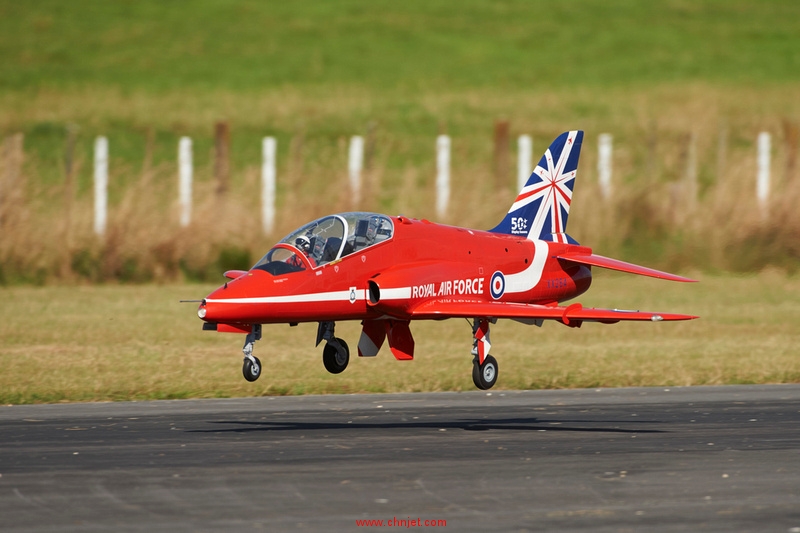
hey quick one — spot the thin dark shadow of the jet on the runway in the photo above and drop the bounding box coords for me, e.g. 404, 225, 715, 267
186, 418, 668, 433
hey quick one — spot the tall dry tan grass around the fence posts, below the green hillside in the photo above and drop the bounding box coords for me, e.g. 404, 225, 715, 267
0, 86, 800, 283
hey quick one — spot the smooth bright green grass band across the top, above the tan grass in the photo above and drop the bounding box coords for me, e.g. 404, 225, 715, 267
0, 0, 800, 93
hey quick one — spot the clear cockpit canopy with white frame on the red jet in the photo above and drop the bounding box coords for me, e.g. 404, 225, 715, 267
253, 212, 394, 276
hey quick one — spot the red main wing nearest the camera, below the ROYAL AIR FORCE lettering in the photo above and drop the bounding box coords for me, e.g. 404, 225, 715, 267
411, 298, 697, 326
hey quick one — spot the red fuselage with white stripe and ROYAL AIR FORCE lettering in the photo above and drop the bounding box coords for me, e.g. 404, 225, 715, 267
201, 217, 592, 326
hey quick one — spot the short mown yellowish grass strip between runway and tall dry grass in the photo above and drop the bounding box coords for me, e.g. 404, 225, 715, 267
0, 271, 800, 404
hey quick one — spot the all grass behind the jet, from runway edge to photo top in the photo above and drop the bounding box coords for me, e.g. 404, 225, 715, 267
0, 0, 800, 402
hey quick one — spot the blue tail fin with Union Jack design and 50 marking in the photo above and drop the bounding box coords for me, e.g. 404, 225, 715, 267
489, 131, 583, 244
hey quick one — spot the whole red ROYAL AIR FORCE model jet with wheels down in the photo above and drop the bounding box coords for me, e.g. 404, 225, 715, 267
198, 131, 697, 389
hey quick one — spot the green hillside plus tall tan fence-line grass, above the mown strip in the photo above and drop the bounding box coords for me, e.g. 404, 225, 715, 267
0, 0, 800, 284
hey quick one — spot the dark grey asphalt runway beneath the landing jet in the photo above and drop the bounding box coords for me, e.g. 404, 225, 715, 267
0, 385, 800, 532
